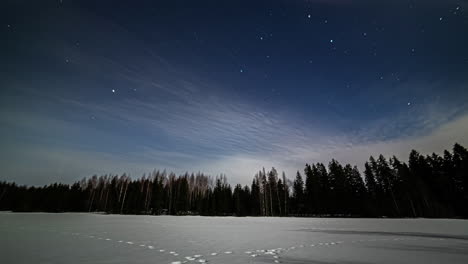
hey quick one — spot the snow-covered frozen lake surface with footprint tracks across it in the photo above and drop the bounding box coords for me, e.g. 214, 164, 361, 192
0, 213, 468, 264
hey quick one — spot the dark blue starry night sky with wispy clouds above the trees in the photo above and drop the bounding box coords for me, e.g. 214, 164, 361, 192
0, 0, 468, 185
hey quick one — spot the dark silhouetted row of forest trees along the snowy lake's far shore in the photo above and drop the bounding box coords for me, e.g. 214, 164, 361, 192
0, 144, 468, 218
